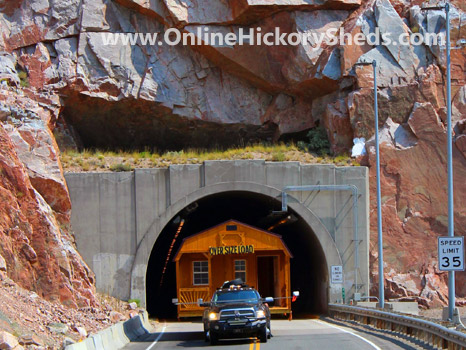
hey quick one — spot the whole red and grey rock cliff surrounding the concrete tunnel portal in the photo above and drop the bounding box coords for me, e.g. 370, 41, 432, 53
0, 0, 466, 305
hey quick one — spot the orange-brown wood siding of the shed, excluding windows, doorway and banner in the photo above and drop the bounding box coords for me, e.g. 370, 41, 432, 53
175, 221, 291, 317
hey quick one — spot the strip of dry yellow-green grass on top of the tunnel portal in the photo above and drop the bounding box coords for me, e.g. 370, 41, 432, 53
60, 143, 359, 172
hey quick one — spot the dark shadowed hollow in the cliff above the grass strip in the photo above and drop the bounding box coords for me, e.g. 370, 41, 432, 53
61, 95, 278, 152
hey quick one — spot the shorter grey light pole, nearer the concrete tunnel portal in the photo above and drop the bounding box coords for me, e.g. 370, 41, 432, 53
355, 60, 385, 309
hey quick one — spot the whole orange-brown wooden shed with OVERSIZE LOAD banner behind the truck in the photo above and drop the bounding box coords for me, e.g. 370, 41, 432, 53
174, 220, 292, 317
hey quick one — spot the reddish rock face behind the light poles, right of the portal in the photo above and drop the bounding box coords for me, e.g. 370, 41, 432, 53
369, 103, 466, 306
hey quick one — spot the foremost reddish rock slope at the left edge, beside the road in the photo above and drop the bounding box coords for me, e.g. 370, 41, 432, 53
0, 125, 95, 308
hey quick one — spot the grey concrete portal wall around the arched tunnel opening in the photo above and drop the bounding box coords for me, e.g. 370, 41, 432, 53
65, 160, 369, 305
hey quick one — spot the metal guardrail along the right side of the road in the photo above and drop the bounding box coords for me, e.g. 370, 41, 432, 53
328, 304, 466, 350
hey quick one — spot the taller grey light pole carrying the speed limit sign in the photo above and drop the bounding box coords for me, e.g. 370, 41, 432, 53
421, 2, 455, 320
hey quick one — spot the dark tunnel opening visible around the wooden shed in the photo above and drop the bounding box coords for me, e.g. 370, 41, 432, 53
146, 191, 328, 319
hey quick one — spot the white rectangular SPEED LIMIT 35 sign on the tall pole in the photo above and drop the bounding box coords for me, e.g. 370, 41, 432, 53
438, 237, 464, 271
